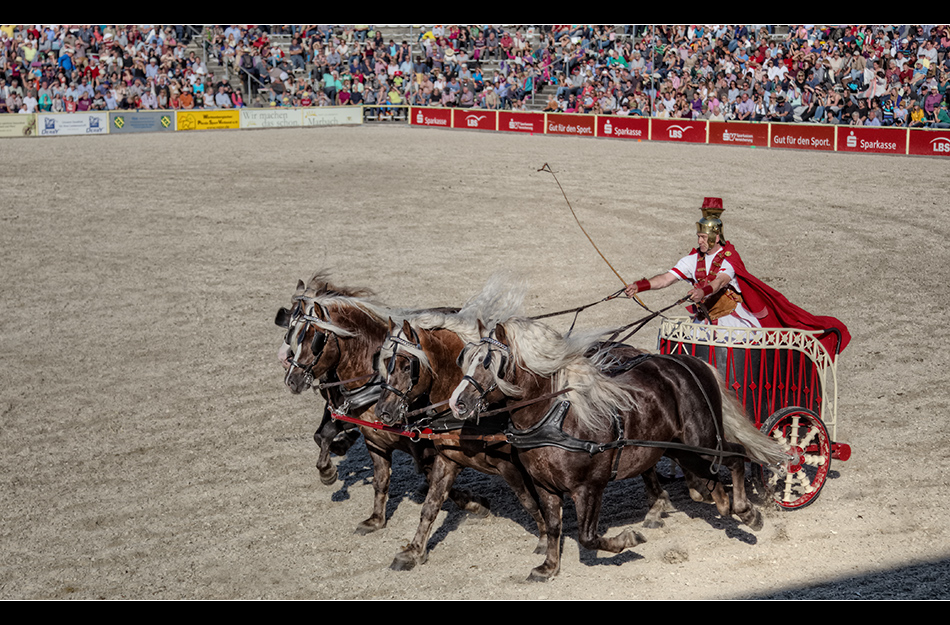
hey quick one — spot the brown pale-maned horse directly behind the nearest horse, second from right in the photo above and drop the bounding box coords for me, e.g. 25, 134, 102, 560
376, 313, 547, 570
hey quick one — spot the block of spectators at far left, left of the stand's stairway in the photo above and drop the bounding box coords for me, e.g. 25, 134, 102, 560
0, 25, 243, 113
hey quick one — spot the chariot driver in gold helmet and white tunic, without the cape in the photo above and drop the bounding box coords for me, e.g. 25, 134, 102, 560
626, 197, 762, 328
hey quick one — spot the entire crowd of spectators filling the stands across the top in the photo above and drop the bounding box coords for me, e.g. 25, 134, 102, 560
0, 24, 950, 127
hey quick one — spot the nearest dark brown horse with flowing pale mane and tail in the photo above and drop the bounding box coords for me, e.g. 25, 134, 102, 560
449, 317, 788, 581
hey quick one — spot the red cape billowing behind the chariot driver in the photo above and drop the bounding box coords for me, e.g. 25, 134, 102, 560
691, 243, 851, 358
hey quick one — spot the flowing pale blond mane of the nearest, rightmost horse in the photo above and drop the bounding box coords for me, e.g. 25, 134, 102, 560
496, 317, 638, 432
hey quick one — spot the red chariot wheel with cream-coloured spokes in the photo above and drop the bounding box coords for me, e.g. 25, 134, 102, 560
760, 407, 831, 510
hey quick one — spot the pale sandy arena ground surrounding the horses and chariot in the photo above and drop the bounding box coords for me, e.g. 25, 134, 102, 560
0, 126, 950, 599
